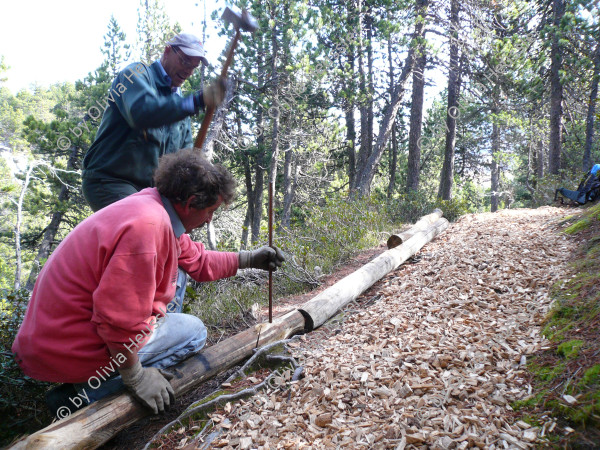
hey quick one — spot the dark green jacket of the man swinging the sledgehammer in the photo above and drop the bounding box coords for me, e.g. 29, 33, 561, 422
83, 61, 192, 190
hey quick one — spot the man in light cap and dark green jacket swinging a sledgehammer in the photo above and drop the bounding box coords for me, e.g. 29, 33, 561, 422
82, 33, 225, 211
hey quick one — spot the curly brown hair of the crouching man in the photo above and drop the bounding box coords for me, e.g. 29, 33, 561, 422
154, 148, 235, 209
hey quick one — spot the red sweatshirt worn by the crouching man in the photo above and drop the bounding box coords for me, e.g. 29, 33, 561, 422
12, 188, 238, 383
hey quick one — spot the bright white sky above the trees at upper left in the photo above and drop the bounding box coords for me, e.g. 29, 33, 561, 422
0, 0, 227, 93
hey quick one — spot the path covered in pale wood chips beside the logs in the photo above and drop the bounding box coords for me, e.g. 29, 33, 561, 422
199, 207, 575, 449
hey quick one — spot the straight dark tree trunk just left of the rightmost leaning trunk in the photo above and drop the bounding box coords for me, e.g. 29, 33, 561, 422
548, 0, 565, 175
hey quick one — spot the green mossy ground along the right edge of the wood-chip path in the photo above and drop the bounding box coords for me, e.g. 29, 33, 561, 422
513, 204, 600, 448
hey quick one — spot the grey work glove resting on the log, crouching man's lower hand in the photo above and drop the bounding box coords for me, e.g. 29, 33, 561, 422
119, 361, 175, 414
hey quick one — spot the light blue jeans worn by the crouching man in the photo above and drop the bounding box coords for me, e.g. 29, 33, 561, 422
74, 312, 207, 403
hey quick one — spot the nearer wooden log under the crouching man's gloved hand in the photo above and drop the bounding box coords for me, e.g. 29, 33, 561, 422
12, 311, 305, 449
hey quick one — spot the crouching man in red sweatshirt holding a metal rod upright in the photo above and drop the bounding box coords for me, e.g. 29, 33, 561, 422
12, 149, 284, 413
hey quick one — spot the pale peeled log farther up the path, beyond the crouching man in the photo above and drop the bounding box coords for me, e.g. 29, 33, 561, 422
299, 218, 449, 331
